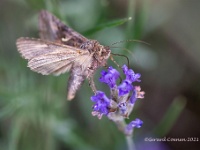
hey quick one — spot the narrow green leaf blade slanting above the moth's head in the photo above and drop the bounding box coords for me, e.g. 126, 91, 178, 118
83, 17, 131, 35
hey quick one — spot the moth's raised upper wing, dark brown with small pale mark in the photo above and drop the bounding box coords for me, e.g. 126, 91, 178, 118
39, 10, 87, 47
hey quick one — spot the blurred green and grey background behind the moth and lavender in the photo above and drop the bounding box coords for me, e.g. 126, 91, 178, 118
0, 0, 200, 150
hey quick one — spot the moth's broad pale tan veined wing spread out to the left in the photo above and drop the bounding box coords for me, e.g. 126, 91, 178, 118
17, 38, 89, 75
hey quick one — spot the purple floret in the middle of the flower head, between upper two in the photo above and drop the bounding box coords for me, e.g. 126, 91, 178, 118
118, 80, 133, 96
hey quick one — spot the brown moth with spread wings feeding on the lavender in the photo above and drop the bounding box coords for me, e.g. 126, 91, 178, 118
16, 10, 111, 100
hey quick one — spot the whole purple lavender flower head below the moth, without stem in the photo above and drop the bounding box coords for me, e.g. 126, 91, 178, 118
91, 65, 145, 134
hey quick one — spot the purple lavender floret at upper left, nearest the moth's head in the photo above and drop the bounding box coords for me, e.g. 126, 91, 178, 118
100, 67, 120, 88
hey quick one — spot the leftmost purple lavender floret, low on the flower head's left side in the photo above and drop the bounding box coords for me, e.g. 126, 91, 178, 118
91, 91, 110, 115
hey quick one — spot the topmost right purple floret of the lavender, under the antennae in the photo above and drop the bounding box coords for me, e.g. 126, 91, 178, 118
122, 65, 141, 82
